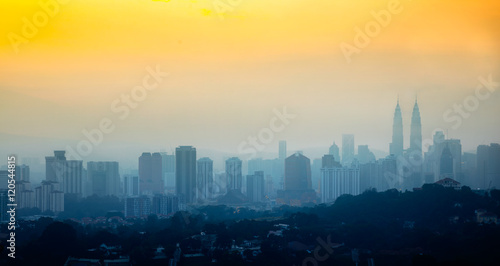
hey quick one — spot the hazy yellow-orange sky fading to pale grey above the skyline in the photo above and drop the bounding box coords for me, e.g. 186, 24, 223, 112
0, 0, 500, 164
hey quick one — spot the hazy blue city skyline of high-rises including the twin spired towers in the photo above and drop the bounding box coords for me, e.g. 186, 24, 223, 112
0, 97, 500, 220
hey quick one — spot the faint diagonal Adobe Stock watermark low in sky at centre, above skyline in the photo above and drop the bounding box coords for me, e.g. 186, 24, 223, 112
238, 106, 297, 159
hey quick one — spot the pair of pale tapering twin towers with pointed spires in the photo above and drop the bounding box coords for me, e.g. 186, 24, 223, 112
389, 98, 422, 157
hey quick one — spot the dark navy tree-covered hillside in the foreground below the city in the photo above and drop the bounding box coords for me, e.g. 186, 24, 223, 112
0, 185, 500, 265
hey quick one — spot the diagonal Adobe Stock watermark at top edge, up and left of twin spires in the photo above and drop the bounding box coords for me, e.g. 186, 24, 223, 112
340, 0, 411, 63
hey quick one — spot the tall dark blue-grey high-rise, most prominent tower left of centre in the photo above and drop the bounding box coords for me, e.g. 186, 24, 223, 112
175, 146, 196, 203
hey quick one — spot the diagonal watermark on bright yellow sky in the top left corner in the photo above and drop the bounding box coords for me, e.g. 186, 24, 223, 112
7, 0, 71, 54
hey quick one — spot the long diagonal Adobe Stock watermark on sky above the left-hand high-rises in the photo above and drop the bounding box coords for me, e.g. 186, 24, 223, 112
66, 65, 168, 160
